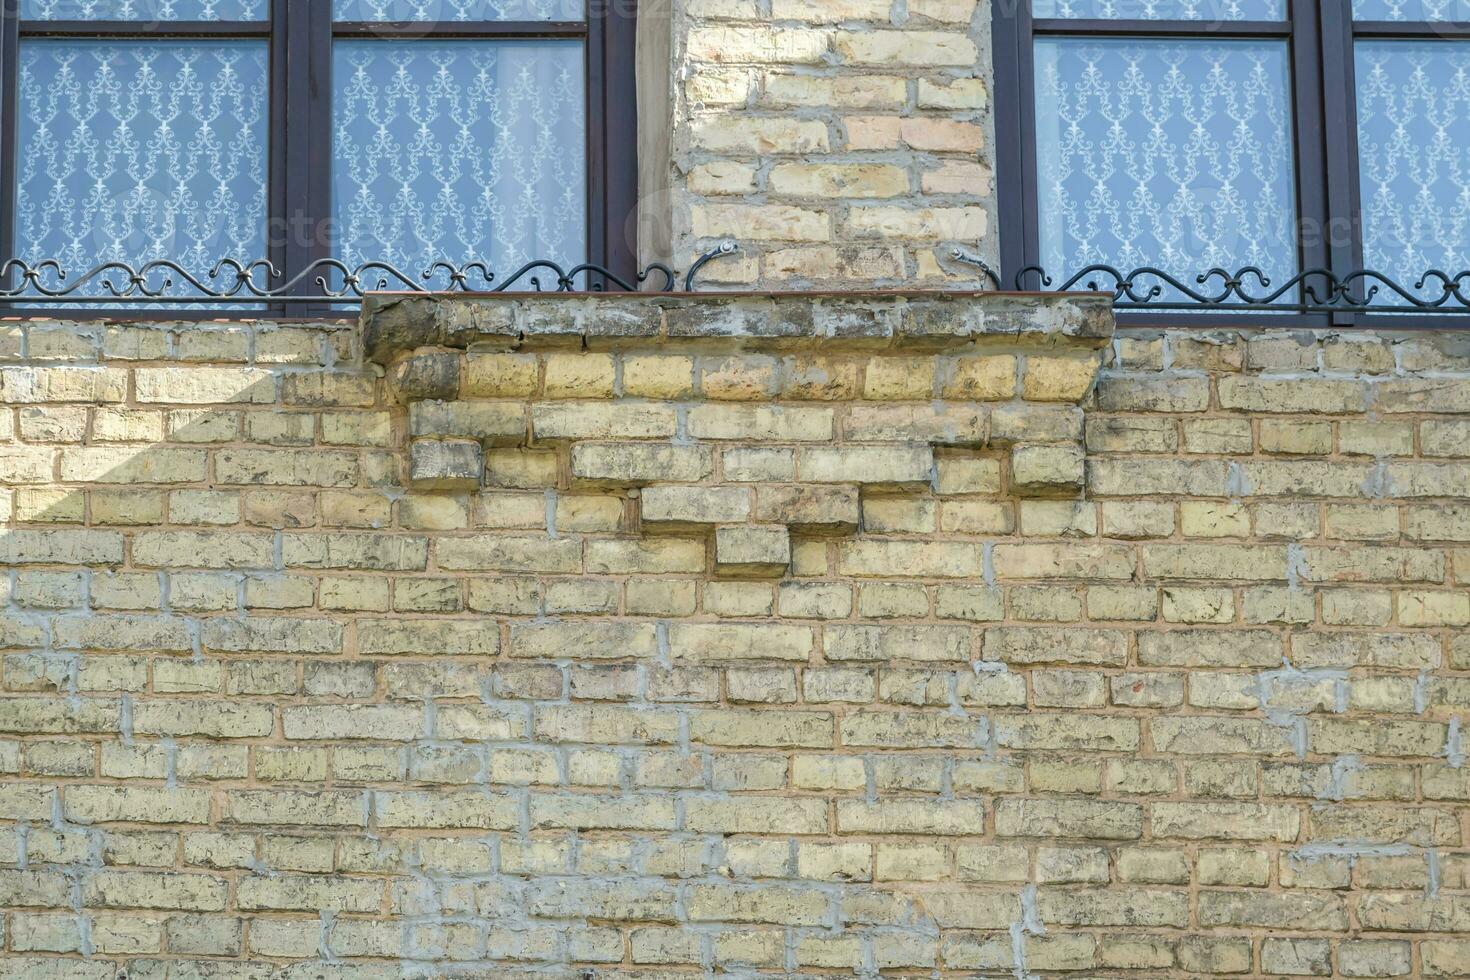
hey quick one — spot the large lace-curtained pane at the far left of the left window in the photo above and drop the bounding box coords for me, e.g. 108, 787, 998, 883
16, 40, 269, 276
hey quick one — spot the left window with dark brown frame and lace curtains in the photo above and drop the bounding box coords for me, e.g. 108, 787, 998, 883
0, 0, 637, 304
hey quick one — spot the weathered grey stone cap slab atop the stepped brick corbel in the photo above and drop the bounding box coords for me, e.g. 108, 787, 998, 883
362, 289, 1114, 364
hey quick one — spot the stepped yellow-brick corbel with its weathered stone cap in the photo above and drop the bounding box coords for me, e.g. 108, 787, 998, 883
363, 292, 1113, 577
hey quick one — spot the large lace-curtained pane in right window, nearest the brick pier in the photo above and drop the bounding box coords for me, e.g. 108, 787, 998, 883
1036, 38, 1297, 298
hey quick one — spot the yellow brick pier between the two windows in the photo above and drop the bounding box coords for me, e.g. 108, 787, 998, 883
670, 0, 995, 288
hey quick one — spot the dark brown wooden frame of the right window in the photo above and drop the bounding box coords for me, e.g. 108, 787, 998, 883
992, 0, 1470, 328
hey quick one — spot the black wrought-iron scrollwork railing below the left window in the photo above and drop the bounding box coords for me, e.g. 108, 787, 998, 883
0, 241, 739, 307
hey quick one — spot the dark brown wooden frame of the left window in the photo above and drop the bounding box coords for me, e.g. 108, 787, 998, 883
0, 0, 638, 319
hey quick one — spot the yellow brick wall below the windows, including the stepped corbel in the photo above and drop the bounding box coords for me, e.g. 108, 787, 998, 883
0, 294, 1470, 980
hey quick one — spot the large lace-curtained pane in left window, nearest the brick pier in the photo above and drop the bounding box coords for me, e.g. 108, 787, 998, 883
332, 41, 587, 285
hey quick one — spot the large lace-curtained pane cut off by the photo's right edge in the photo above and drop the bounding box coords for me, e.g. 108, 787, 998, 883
1355, 41, 1470, 300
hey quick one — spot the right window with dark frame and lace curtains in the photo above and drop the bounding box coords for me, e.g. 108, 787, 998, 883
995, 0, 1470, 323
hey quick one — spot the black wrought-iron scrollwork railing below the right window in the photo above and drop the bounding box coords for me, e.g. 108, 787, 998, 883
951, 248, 1470, 316
